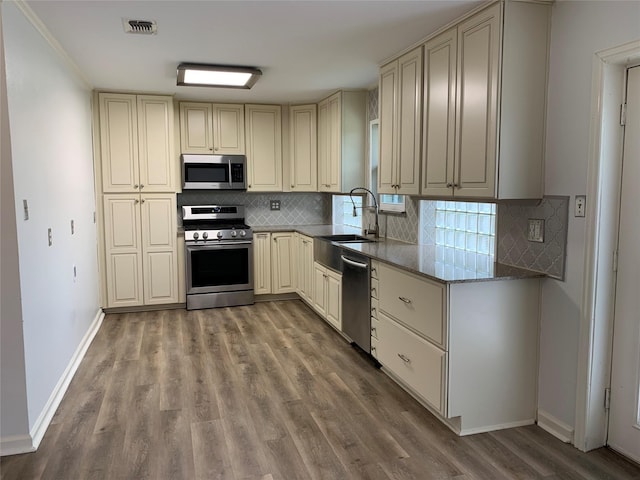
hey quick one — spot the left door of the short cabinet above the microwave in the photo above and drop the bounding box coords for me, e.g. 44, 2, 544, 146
180, 102, 213, 154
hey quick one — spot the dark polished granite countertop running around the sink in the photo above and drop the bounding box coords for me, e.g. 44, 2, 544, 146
253, 225, 545, 283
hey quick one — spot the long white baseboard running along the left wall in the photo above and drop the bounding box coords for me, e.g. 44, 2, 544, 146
28, 309, 104, 453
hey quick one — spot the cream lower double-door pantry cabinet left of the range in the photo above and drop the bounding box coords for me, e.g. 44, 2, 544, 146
103, 194, 179, 308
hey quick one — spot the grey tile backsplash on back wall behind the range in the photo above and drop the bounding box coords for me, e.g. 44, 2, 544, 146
178, 190, 331, 226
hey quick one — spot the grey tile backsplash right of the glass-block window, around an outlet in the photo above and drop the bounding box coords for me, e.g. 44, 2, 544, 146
498, 196, 569, 280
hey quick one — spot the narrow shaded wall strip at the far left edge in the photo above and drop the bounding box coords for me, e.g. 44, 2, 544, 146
0, 5, 30, 451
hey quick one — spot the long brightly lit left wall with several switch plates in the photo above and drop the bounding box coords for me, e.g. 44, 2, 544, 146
0, 2, 99, 446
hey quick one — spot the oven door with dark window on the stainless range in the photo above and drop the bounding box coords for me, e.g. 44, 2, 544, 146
187, 245, 253, 293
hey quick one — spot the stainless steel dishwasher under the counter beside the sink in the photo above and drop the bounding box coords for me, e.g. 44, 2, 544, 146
340, 249, 371, 353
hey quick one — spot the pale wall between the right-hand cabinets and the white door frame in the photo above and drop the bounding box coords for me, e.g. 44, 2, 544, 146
539, 0, 640, 428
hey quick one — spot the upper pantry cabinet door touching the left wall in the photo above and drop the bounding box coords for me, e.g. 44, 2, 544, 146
98, 93, 140, 193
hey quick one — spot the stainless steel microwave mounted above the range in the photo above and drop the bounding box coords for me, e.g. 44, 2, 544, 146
180, 155, 247, 190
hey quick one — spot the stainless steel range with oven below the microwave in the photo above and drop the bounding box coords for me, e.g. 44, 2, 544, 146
182, 205, 253, 310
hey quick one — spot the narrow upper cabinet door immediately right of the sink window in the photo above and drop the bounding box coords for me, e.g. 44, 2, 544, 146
378, 61, 398, 194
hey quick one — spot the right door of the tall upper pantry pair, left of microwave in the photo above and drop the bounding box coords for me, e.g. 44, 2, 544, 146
137, 95, 178, 192
